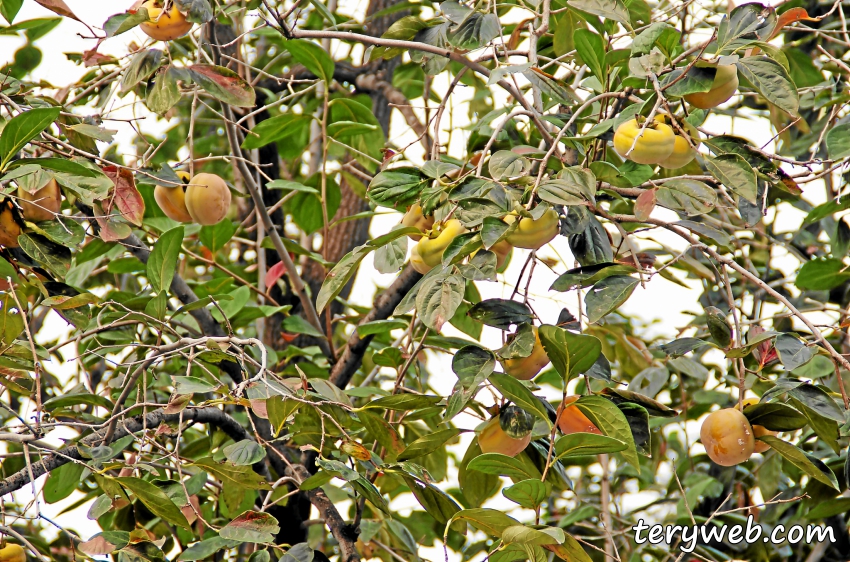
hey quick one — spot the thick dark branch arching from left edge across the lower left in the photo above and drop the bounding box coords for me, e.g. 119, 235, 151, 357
0, 408, 252, 497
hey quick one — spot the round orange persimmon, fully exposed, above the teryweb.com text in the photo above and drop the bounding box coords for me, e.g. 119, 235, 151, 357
699, 408, 755, 466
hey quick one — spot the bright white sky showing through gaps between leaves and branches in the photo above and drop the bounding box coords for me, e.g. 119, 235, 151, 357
0, 0, 836, 560
